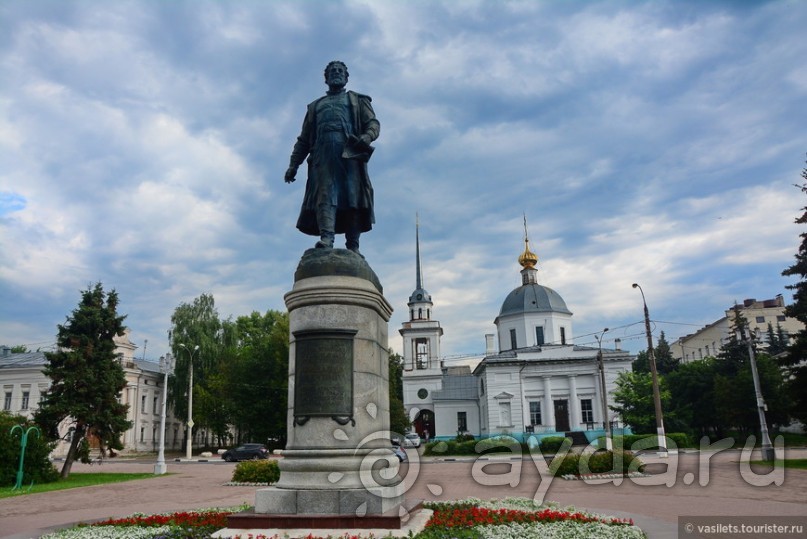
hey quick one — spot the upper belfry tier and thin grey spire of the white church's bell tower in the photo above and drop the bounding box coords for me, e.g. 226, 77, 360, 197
400, 215, 443, 374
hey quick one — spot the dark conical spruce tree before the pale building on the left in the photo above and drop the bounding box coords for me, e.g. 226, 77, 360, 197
36, 283, 131, 477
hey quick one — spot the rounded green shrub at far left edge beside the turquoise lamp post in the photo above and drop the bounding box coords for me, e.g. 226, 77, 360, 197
0, 412, 59, 488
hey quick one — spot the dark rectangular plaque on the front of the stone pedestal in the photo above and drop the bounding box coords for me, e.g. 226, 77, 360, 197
294, 329, 356, 425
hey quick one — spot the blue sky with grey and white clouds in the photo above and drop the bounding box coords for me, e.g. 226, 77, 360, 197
0, 0, 807, 359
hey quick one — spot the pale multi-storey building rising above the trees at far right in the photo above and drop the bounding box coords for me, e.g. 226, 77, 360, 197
671, 294, 804, 363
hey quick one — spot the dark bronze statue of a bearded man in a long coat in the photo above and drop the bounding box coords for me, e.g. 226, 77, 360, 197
286, 61, 381, 253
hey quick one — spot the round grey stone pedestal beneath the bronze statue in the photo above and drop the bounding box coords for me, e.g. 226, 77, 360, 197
241, 249, 406, 527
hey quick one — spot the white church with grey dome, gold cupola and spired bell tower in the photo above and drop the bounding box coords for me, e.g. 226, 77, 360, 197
399, 226, 635, 443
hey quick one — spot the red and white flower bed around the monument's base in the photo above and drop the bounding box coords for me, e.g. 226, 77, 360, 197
43, 498, 646, 539
